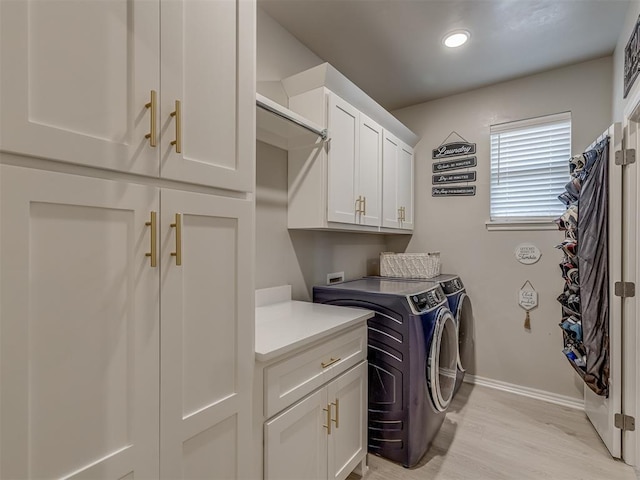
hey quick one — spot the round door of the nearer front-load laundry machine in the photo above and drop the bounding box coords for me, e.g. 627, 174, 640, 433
427, 308, 458, 412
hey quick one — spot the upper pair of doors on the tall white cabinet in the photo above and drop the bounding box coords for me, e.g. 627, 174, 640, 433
0, 0, 255, 191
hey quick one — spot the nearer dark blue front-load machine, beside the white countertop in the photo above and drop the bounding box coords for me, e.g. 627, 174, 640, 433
313, 278, 458, 467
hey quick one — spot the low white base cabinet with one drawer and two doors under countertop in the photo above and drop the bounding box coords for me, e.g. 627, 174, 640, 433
256, 325, 367, 480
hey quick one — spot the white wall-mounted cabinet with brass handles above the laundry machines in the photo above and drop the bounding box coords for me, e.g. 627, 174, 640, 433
283, 64, 418, 233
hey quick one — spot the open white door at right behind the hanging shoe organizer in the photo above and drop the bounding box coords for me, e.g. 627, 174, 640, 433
584, 123, 622, 458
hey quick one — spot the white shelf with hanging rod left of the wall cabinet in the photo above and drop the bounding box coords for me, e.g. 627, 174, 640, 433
256, 93, 327, 150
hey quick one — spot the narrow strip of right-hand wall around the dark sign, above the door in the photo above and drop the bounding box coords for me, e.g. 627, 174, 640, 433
612, 0, 640, 122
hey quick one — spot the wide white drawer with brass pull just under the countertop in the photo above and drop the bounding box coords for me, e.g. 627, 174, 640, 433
264, 325, 367, 418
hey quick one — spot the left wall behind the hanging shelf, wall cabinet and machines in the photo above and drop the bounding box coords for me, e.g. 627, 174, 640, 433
255, 8, 387, 300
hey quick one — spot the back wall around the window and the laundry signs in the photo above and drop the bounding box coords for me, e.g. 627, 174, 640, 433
390, 57, 612, 398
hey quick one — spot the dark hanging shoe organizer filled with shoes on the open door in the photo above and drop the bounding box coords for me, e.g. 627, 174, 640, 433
556, 138, 609, 396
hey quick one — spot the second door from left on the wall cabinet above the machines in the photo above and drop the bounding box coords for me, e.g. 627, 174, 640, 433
356, 113, 382, 227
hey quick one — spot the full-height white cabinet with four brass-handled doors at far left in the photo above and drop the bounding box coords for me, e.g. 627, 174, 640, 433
0, 0, 255, 479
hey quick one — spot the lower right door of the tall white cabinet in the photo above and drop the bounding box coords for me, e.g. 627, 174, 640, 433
160, 189, 255, 480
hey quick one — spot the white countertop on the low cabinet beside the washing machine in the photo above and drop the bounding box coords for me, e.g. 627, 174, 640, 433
256, 287, 373, 362
